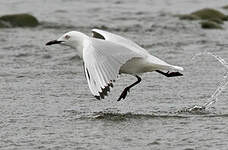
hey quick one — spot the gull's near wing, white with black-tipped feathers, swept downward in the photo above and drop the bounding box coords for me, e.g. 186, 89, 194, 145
83, 38, 140, 99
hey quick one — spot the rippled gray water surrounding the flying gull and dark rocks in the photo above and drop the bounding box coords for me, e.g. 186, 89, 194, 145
0, 0, 228, 150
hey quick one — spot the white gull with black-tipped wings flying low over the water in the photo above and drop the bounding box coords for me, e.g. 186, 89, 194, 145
46, 29, 183, 101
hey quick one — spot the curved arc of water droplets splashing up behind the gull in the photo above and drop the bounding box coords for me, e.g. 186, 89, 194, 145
185, 52, 228, 112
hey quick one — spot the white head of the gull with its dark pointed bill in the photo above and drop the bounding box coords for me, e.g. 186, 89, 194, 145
46, 31, 86, 48
